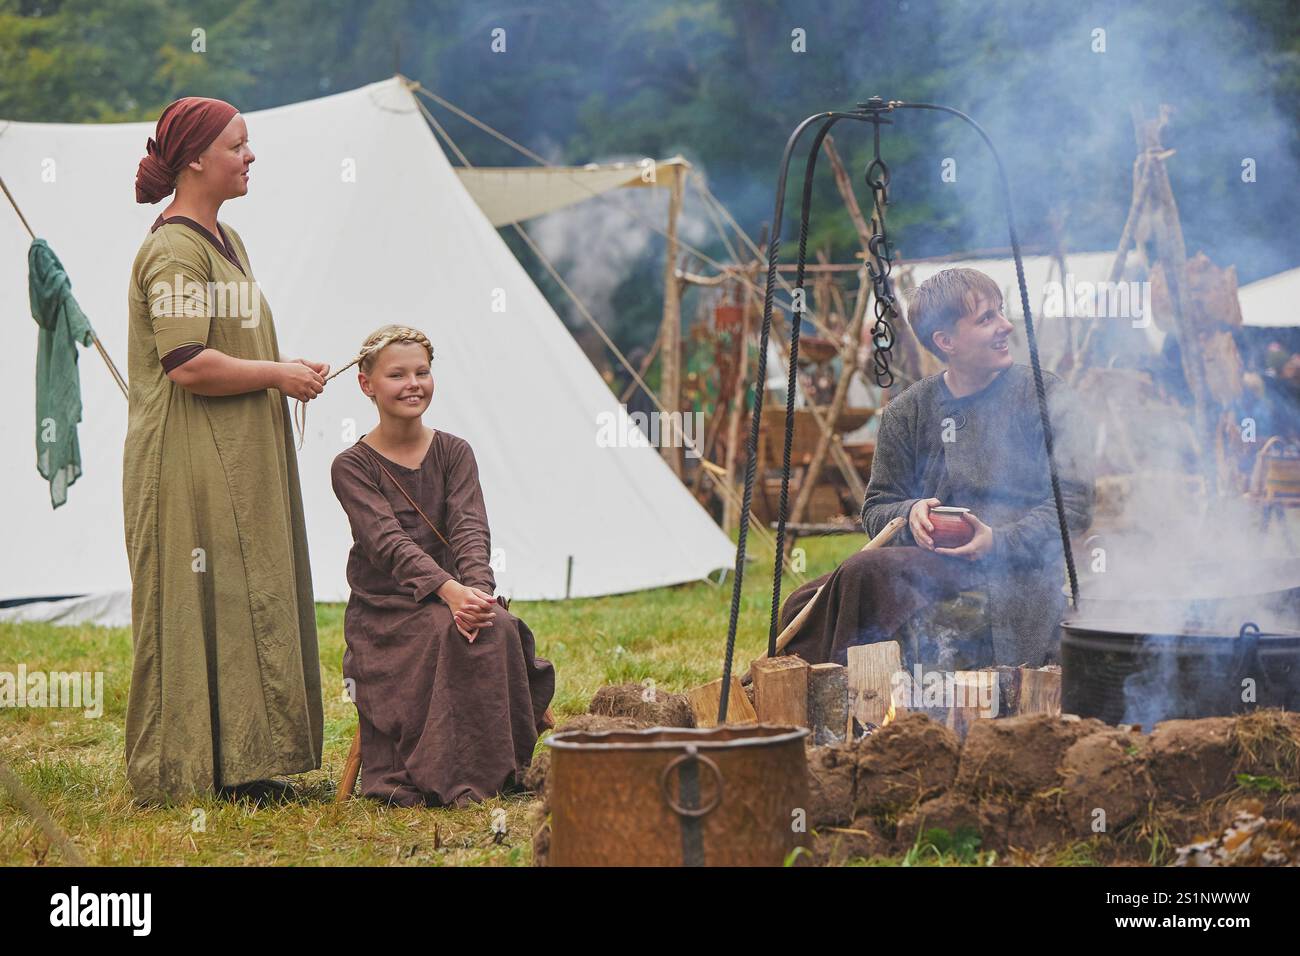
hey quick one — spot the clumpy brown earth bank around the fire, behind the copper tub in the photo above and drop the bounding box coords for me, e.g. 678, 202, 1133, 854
525, 702, 1300, 866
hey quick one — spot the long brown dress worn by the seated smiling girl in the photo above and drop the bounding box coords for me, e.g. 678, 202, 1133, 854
330, 431, 555, 806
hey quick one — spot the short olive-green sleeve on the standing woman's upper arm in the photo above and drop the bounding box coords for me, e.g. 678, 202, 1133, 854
140, 235, 212, 362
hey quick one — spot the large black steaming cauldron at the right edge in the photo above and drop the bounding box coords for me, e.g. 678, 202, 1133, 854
1061, 620, 1300, 730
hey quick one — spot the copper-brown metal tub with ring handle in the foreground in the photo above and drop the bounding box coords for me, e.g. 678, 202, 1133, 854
546, 724, 809, 866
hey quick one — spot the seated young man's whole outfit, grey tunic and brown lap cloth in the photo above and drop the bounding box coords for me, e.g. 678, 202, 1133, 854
764, 365, 1096, 669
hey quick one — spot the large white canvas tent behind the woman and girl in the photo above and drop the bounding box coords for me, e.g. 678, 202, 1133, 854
0, 78, 735, 623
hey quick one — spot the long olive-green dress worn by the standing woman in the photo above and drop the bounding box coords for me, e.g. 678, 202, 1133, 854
122, 217, 322, 801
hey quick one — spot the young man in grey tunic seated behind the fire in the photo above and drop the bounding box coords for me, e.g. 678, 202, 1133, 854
781, 269, 1093, 669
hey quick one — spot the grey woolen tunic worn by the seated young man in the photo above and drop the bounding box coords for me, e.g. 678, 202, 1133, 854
862, 365, 1093, 666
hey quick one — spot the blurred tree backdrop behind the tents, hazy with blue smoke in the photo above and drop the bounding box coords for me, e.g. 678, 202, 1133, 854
0, 0, 1300, 345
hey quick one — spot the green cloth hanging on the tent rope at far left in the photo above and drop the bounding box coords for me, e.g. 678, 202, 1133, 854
27, 239, 95, 507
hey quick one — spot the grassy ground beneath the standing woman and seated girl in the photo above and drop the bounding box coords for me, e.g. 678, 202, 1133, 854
0, 536, 865, 866
